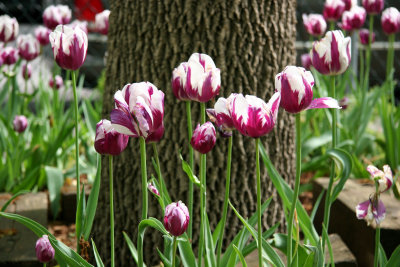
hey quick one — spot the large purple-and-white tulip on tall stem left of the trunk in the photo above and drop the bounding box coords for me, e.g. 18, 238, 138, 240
50, 25, 88, 70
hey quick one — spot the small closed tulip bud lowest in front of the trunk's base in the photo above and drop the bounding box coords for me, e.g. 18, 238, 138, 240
164, 201, 190, 236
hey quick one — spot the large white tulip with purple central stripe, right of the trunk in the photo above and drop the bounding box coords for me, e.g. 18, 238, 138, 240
311, 31, 351, 75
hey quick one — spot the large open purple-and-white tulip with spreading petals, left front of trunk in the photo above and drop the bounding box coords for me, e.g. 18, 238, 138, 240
111, 82, 164, 142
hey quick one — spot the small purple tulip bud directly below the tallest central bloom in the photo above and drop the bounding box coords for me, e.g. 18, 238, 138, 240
190, 121, 217, 154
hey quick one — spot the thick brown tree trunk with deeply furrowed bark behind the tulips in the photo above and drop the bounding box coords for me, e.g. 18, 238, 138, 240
93, 0, 296, 266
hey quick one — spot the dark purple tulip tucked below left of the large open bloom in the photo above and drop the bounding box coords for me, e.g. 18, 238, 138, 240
94, 120, 129, 156
